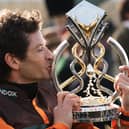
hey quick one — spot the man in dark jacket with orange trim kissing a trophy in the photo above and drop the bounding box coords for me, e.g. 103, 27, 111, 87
0, 10, 129, 129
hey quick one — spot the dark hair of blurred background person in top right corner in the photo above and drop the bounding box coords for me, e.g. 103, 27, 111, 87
120, 0, 129, 21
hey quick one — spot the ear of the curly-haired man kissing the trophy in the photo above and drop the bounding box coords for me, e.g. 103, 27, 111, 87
4, 53, 20, 70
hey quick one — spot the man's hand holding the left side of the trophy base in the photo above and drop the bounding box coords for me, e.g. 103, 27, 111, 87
54, 92, 80, 128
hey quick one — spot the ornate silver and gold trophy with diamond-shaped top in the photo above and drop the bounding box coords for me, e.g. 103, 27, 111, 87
52, 1, 129, 122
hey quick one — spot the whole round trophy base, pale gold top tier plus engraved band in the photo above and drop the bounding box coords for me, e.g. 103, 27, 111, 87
73, 97, 119, 122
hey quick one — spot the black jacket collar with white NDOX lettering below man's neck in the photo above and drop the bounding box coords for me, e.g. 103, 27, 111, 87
0, 81, 38, 101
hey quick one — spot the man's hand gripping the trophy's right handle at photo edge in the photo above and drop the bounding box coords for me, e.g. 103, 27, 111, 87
114, 66, 129, 111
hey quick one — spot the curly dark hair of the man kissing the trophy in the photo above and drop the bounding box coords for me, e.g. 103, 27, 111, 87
0, 9, 41, 78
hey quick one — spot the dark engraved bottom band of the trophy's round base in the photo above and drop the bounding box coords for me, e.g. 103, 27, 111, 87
73, 104, 120, 122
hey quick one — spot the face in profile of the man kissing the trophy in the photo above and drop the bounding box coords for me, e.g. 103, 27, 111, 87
20, 31, 53, 82
